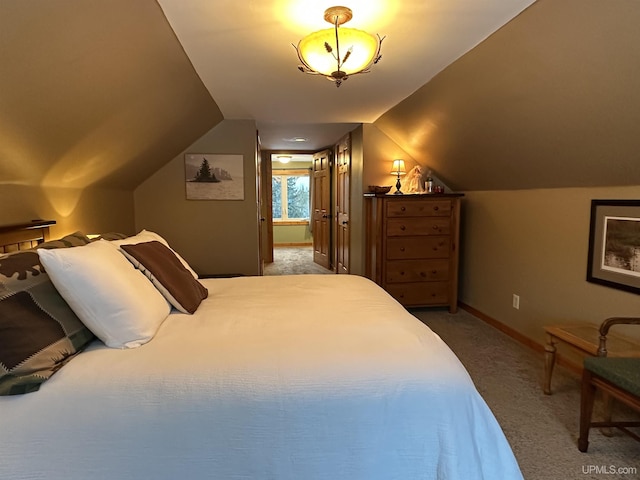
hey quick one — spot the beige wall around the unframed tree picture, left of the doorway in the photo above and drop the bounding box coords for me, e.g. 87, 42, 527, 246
134, 120, 259, 275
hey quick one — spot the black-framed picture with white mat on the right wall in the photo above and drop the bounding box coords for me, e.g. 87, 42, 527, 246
587, 200, 640, 294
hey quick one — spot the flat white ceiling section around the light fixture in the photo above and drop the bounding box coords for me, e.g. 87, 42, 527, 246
158, 0, 533, 150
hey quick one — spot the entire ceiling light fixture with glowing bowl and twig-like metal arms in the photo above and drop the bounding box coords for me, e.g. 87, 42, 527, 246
293, 7, 385, 87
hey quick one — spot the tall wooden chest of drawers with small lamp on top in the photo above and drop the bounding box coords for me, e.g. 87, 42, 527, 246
365, 194, 463, 313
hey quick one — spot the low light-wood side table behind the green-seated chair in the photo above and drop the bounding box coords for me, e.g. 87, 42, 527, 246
543, 324, 640, 395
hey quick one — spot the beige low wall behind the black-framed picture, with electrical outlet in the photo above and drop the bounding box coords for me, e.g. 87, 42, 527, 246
460, 187, 640, 344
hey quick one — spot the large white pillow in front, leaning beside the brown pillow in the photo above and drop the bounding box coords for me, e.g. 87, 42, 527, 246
38, 240, 171, 348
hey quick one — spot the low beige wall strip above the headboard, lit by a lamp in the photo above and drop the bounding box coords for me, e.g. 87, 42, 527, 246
0, 185, 135, 238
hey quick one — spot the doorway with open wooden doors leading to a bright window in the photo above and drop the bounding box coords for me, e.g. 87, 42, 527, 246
260, 134, 351, 275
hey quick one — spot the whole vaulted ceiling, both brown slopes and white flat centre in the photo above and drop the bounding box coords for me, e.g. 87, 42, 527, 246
0, 0, 640, 190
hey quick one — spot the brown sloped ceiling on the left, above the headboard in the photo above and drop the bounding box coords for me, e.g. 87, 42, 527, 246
0, 0, 222, 190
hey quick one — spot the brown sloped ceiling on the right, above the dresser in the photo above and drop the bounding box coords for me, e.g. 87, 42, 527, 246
375, 0, 640, 190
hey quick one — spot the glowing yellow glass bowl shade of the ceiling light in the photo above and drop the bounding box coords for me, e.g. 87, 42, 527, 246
298, 27, 380, 77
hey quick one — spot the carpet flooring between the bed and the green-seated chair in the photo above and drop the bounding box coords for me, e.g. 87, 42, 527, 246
411, 309, 640, 480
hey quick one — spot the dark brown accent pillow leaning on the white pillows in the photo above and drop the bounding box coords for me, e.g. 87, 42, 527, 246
120, 240, 209, 313
